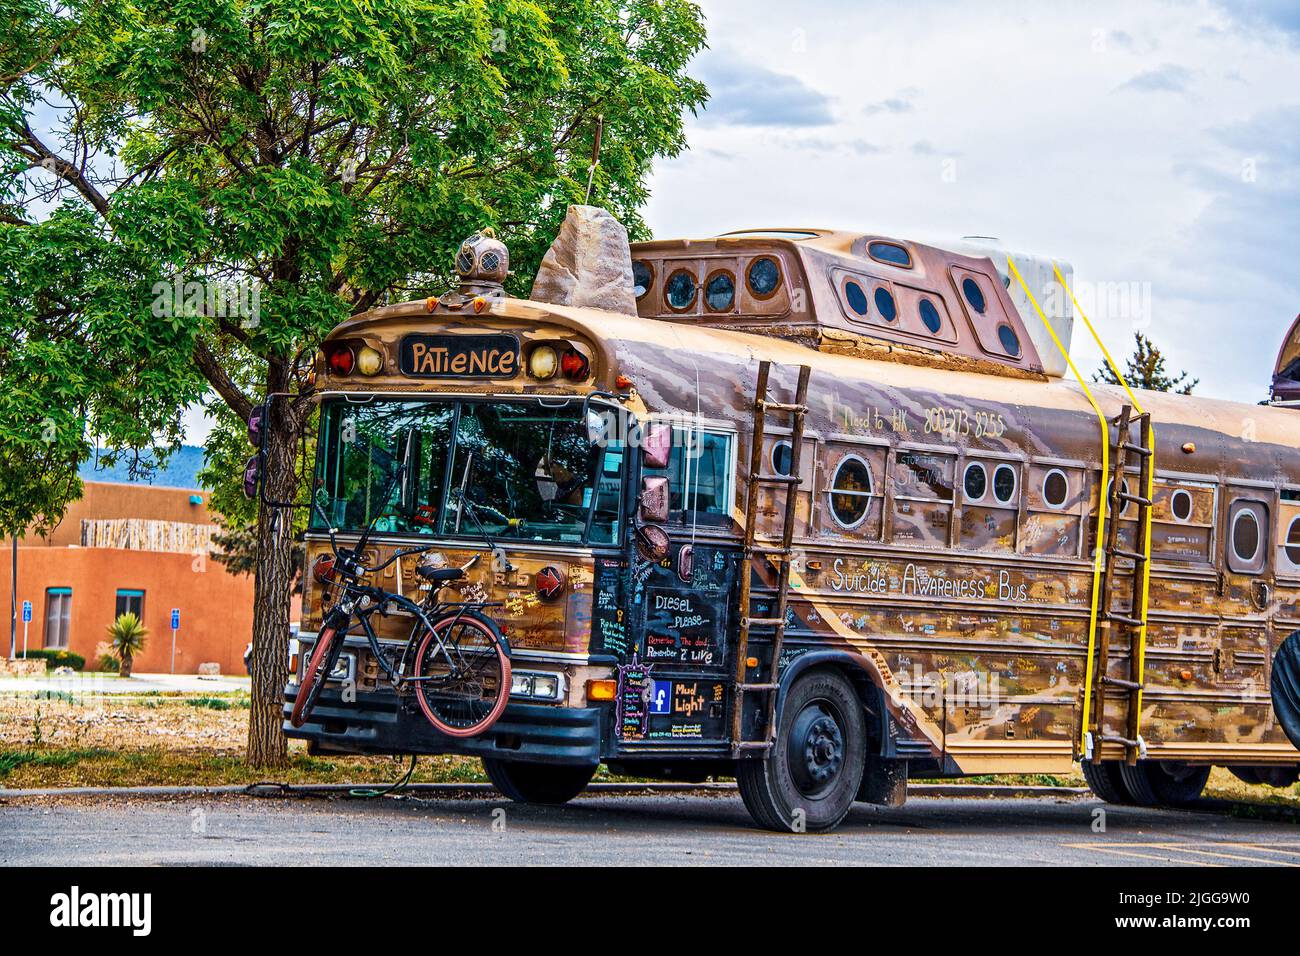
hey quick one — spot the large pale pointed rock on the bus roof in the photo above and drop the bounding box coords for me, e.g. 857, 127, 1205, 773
529, 206, 637, 315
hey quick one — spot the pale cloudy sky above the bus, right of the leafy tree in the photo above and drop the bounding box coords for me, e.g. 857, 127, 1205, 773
646, 0, 1300, 402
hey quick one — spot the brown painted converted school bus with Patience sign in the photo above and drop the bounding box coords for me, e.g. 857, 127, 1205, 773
286, 218, 1300, 829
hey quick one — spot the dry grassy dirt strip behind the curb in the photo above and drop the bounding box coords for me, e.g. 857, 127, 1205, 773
0, 693, 1300, 806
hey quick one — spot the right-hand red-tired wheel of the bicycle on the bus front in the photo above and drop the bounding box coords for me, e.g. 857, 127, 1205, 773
415, 614, 510, 737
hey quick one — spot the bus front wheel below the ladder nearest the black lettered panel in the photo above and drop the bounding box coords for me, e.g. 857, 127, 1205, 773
736, 671, 867, 832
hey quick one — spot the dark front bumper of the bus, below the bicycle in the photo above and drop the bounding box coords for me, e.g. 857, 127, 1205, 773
283, 685, 602, 766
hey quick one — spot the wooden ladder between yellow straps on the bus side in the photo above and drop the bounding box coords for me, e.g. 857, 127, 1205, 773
1088, 405, 1154, 763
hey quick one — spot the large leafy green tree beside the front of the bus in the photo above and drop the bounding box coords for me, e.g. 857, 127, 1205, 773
0, 0, 705, 766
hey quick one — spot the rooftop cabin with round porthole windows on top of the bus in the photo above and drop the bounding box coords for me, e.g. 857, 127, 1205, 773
632, 229, 1074, 378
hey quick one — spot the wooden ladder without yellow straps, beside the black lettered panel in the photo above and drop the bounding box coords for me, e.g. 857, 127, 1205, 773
731, 362, 811, 757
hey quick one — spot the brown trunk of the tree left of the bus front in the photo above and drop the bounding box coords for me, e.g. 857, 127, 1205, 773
248, 388, 298, 767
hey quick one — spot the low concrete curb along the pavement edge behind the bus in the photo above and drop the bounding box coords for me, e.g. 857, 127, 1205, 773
0, 782, 1088, 800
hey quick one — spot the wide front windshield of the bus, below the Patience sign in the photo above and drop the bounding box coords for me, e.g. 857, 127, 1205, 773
312, 399, 625, 544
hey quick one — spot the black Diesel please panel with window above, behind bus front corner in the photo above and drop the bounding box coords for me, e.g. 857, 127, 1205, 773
615, 425, 740, 749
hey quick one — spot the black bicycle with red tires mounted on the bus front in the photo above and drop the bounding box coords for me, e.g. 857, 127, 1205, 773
290, 501, 511, 737
